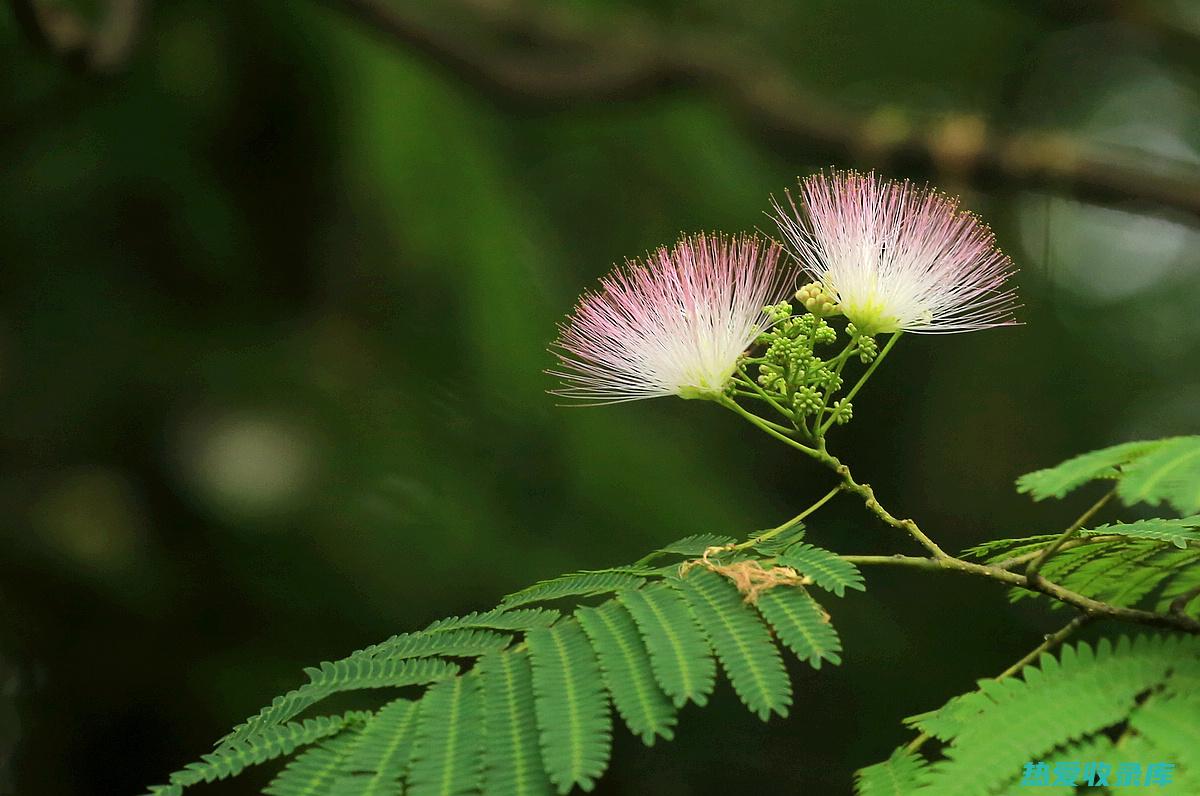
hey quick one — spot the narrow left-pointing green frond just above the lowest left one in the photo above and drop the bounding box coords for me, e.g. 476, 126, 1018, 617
221, 658, 458, 747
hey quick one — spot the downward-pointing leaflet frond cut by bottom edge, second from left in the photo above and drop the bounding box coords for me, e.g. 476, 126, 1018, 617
340, 699, 420, 796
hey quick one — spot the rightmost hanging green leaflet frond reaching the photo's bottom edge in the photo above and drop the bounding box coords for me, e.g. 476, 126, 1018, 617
526, 621, 612, 794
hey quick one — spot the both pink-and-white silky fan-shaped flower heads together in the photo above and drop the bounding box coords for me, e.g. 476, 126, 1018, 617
553, 172, 1015, 403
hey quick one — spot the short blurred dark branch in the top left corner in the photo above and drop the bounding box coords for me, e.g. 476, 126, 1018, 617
12, 0, 149, 74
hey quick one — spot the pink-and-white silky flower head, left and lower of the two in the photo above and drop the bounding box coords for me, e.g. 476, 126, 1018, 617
550, 234, 790, 403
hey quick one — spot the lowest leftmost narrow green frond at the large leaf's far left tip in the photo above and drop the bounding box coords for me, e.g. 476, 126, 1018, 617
162, 711, 371, 785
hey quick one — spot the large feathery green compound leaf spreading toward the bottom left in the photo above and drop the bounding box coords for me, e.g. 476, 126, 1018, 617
151, 529, 864, 796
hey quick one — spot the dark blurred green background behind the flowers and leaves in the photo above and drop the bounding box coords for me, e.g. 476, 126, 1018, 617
0, 0, 1200, 796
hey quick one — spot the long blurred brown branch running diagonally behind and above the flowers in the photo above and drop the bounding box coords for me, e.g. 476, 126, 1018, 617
320, 0, 1200, 216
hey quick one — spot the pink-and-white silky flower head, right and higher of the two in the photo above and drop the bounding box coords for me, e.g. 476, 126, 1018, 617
774, 172, 1016, 335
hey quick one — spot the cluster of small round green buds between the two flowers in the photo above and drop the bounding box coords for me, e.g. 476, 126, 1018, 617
731, 283, 878, 437
